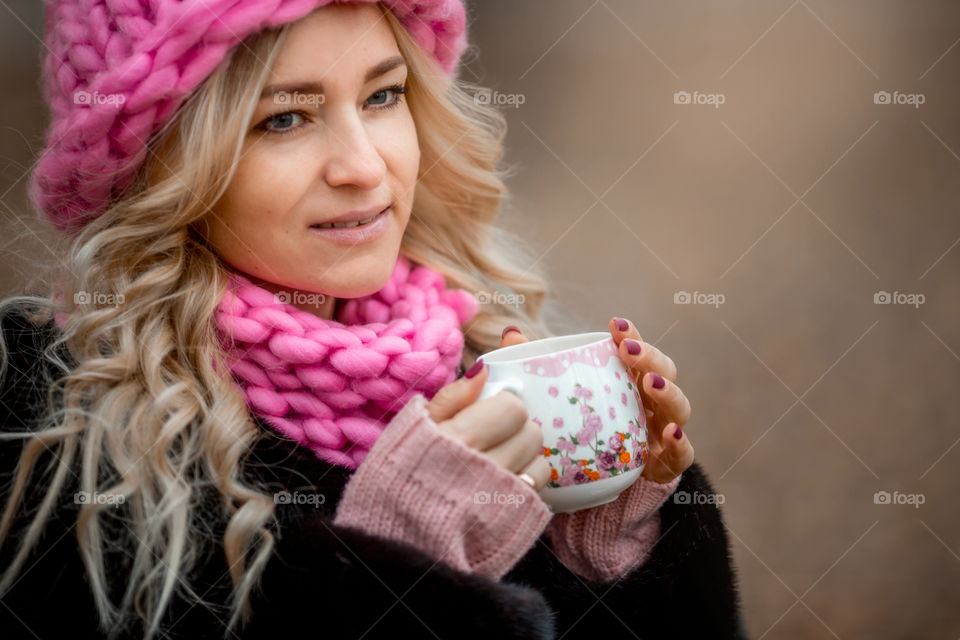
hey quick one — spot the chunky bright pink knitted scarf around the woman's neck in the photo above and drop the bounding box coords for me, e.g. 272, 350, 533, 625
216, 256, 477, 469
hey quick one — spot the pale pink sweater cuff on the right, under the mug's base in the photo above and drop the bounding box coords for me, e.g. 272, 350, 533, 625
547, 474, 682, 582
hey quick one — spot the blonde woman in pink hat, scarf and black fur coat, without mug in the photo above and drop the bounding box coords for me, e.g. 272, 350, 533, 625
0, 0, 739, 638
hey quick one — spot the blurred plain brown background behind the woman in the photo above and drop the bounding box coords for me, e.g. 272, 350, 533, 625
0, 0, 960, 639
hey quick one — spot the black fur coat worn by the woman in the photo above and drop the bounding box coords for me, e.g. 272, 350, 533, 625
0, 314, 744, 640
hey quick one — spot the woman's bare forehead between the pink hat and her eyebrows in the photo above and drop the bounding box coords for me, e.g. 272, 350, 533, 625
268, 3, 399, 85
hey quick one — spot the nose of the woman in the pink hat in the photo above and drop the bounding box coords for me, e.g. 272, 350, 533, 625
325, 112, 387, 189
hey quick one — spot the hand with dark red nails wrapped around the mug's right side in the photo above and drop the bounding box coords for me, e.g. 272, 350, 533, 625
500, 318, 693, 484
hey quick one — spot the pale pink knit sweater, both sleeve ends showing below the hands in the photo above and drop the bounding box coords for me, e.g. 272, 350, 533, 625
334, 394, 680, 581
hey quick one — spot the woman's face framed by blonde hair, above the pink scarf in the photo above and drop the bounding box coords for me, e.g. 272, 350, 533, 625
201, 4, 420, 317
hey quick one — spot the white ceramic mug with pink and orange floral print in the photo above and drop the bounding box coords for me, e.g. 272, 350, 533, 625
478, 331, 647, 513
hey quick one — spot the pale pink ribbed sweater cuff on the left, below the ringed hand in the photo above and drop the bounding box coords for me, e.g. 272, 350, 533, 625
334, 394, 552, 580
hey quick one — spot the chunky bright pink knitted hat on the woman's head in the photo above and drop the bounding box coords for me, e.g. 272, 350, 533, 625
29, 0, 466, 231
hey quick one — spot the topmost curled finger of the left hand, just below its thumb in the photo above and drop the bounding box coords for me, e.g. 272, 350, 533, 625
443, 391, 528, 452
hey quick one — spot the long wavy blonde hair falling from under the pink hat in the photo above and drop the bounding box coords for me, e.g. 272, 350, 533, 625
0, 5, 576, 638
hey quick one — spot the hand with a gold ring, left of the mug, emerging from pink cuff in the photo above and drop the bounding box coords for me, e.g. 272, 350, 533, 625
427, 365, 550, 492
